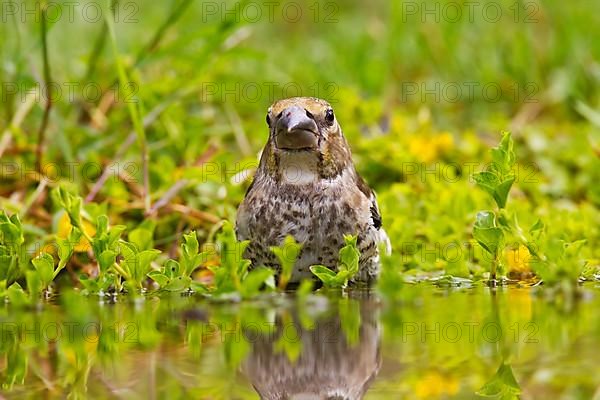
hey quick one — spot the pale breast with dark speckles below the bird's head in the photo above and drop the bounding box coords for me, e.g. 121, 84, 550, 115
237, 170, 381, 282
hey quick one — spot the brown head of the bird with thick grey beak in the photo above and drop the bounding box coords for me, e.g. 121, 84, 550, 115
261, 97, 352, 182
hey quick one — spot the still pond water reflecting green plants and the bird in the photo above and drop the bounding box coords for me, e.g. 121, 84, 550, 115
0, 284, 600, 399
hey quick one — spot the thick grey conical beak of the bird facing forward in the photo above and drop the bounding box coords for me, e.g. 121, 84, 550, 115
275, 106, 319, 150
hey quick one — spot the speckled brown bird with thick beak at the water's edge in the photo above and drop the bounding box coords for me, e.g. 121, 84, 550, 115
235, 97, 391, 285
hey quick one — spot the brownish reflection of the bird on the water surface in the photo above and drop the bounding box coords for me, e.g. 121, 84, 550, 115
242, 300, 381, 400
